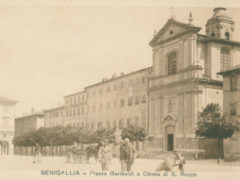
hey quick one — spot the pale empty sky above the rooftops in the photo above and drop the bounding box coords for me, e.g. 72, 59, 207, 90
0, 0, 240, 116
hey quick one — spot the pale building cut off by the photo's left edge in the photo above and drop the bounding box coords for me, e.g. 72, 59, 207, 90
0, 97, 17, 155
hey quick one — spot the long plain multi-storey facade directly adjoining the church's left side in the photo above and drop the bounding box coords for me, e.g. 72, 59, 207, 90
86, 68, 151, 129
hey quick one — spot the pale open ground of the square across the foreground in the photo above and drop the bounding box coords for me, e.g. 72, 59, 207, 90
0, 156, 240, 180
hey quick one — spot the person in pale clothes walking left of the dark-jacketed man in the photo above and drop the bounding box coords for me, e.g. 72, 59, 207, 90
98, 140, 112, 171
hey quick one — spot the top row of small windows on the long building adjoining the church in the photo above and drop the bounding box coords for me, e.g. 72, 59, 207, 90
88, 76, 147, 97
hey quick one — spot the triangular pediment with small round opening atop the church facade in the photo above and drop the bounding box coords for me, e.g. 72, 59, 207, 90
150, 19, 201, 46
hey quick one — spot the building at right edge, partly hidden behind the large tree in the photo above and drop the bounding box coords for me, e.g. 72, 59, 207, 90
218, 65, 240, 160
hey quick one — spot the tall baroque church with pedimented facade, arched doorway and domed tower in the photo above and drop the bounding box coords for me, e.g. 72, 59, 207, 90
148, 7, 240, 156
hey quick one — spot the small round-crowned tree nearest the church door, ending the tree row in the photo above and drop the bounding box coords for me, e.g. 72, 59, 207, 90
121, 125, 148, 149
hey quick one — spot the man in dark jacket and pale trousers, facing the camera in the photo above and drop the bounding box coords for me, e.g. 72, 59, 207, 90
120, 138, 135, 171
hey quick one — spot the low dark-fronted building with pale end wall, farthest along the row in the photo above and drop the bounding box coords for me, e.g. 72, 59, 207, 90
15, 112, 44, 137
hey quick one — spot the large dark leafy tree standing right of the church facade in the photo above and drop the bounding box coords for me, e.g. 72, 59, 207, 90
196, 103, 240, 159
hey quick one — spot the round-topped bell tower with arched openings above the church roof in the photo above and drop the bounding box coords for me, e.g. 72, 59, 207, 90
206, 7, 235, 40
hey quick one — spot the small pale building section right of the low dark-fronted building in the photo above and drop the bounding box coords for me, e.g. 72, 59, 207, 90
44, 106, 65, 127
